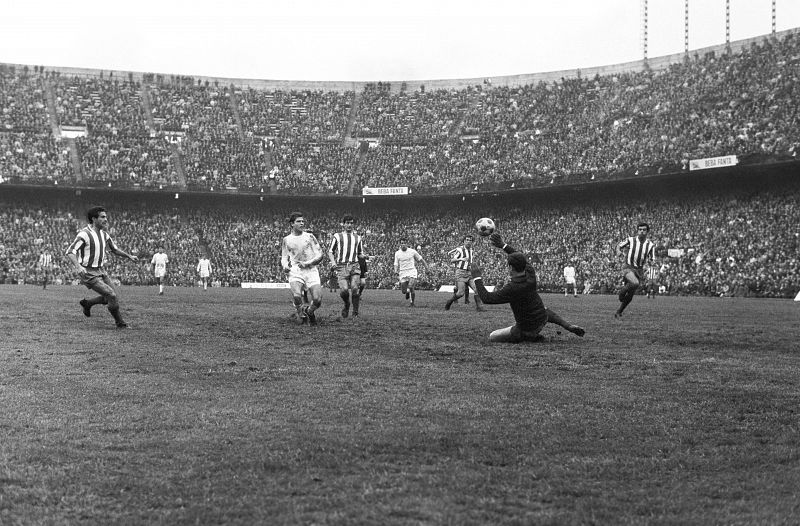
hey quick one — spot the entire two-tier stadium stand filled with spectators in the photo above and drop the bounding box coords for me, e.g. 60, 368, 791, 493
0, 31, 800, 297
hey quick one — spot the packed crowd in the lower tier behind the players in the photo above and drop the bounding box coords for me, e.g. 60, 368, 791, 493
0, 177, 800, 297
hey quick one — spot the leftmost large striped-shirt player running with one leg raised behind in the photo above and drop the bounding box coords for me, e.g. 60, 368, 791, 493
66, 206, 139, 329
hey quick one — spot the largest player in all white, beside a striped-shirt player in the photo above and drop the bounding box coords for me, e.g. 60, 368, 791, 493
281, 212, 323, 325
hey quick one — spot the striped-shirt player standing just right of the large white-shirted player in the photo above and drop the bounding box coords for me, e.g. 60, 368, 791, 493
328, 214, 366, 318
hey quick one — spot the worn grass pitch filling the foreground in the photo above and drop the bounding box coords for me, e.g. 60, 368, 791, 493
0, 285, 800, 525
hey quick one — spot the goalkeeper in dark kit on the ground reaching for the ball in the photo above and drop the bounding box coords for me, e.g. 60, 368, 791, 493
470, 232, 586, 343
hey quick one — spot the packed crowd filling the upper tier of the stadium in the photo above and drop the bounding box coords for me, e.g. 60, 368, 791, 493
0, 29, 800, 195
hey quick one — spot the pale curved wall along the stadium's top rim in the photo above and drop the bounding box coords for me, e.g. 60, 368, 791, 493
6, 28, 800, 92
